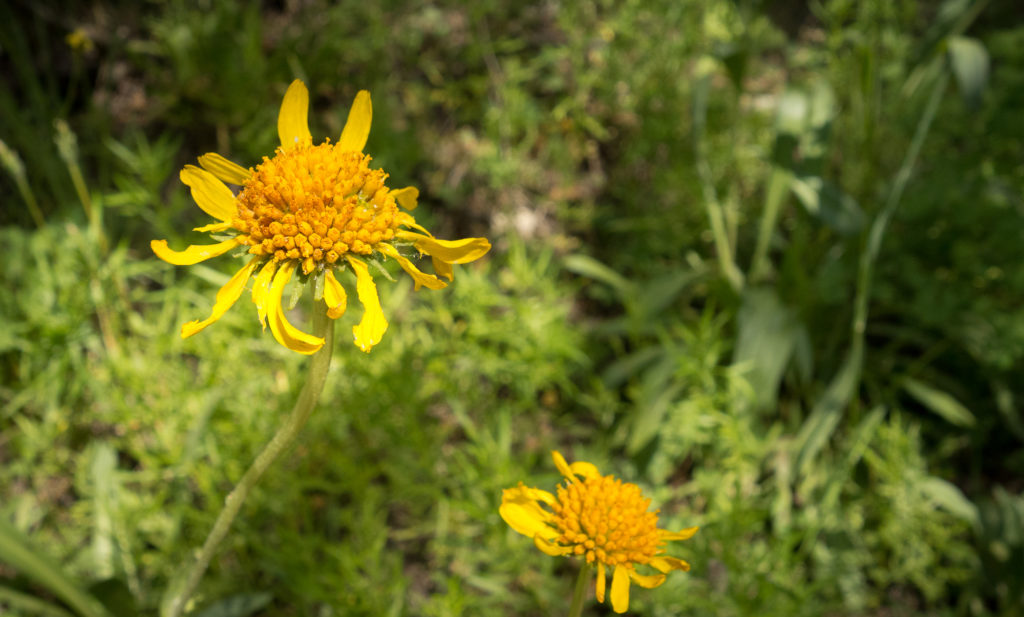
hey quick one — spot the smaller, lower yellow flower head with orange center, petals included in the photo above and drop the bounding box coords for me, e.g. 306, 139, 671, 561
499, 451, 697, 613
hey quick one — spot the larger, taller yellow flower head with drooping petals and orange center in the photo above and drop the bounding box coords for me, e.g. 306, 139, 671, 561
150, 80, 490, 354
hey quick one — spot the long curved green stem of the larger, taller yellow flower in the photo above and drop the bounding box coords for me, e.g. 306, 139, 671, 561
160, 301, 334, 617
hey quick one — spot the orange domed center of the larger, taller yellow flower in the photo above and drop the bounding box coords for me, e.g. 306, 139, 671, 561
231, 140, 398, 274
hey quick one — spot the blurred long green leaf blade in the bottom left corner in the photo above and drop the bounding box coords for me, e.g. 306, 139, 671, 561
0, 517, 110, 617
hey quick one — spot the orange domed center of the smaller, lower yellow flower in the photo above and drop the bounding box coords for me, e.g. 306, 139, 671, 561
552, 476, 660, 566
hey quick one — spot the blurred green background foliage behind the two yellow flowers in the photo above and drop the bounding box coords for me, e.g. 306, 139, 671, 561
0, 0, 1024, 617
